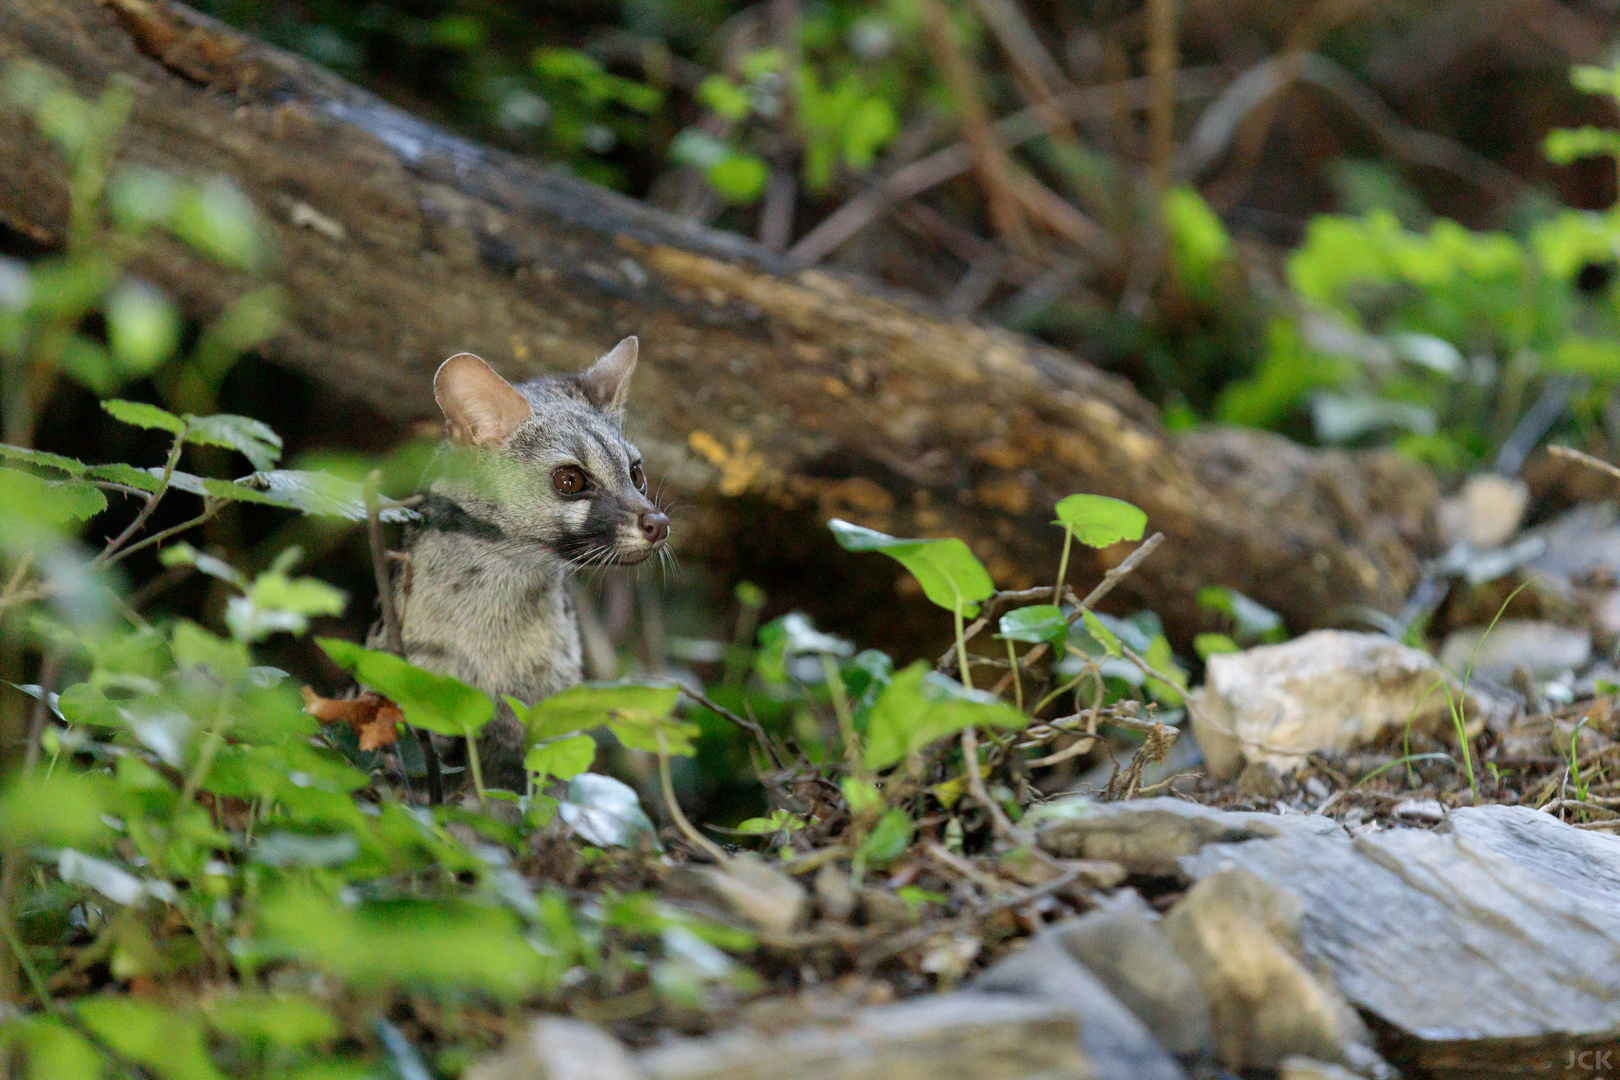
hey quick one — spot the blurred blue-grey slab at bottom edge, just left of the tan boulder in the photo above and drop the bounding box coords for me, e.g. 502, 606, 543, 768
974, 928, 1207, 1080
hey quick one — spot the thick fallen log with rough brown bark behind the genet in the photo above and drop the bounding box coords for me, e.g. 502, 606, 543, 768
0, 0, 1435, 635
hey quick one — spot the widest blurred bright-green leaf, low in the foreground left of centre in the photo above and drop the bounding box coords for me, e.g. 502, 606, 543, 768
258, 887, 546, 999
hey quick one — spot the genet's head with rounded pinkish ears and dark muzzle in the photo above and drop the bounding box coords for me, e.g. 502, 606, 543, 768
433, 337, 669, 567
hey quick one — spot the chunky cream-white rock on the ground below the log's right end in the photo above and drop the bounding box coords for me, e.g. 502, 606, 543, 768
1191, 630, 1499, 779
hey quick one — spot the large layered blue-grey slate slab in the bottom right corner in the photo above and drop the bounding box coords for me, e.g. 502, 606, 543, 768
1183, 806, 1620, 1077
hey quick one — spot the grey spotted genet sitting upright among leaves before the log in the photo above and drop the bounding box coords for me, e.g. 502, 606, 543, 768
382, 337, 667, 789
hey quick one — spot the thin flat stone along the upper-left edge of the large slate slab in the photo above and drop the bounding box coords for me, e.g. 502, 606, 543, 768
1037, 797, 1348, 878
